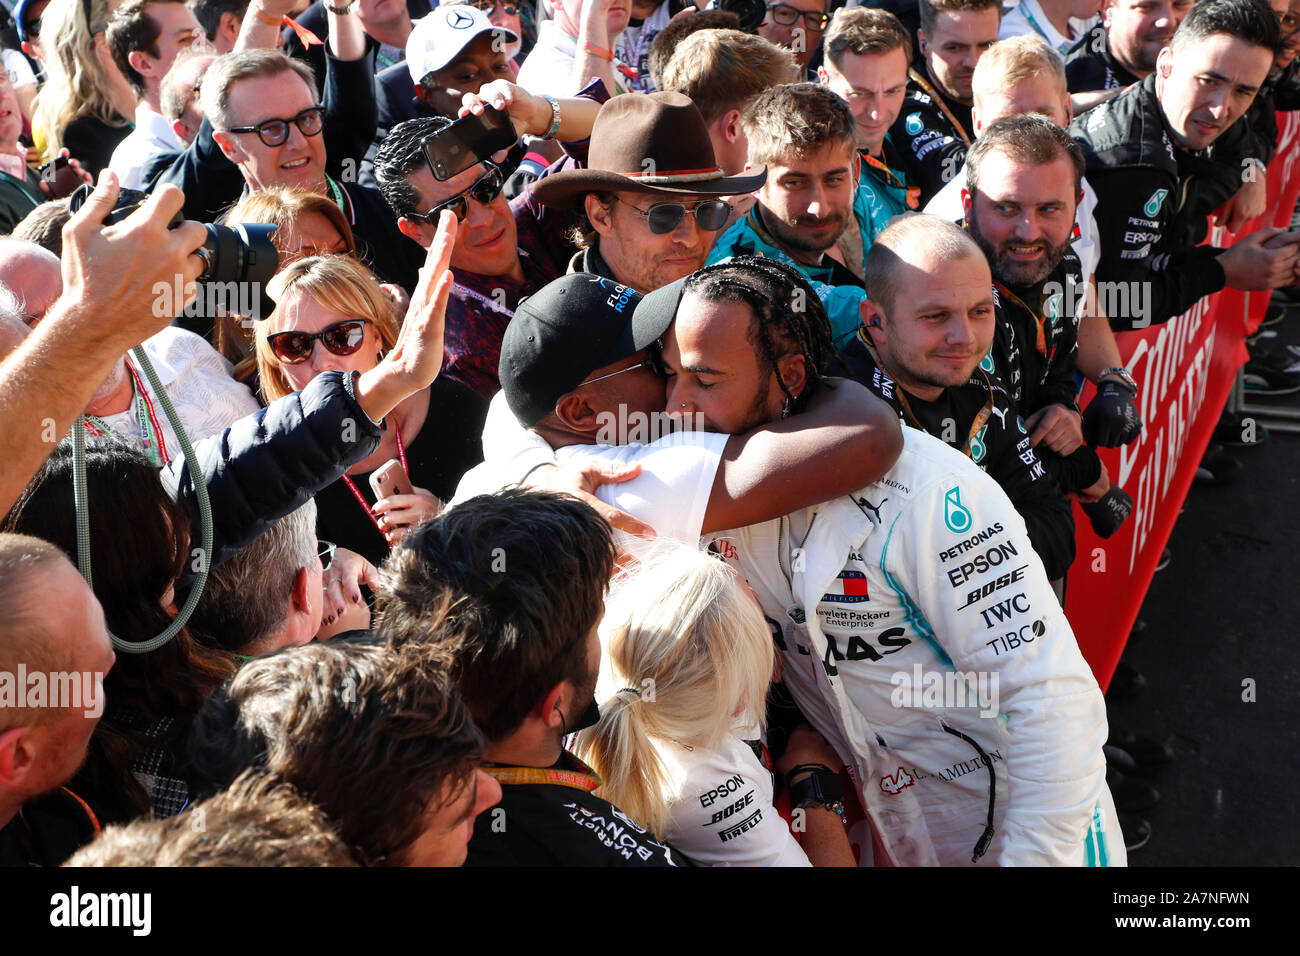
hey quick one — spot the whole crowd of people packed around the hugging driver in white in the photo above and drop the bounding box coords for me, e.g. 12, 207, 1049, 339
0, 0, 1300, 866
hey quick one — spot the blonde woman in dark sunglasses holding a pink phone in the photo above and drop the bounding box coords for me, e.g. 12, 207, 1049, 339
255, 255, 488, 564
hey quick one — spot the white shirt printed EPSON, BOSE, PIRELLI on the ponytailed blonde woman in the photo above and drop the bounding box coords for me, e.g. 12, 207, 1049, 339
655, 723, 813, 866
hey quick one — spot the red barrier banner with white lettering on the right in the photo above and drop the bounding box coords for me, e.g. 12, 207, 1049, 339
1066, 113, 1300, 688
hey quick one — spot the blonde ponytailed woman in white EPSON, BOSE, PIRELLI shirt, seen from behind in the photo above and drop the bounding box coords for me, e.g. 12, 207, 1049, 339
577, 545, 853, 866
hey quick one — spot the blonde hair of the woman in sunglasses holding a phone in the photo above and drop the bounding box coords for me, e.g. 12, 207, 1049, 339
254, 255, 398, 402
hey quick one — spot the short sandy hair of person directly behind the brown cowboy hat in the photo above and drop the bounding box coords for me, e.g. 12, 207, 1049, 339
659, 30, 800, 124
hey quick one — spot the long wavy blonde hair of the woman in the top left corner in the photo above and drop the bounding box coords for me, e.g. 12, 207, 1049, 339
33, 0, 128, 160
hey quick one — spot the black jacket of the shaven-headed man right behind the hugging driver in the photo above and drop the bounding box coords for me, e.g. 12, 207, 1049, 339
828, 333, 1075, 580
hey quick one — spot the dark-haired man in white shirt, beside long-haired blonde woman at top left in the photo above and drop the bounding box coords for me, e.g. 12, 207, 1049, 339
107, 0, 200, 189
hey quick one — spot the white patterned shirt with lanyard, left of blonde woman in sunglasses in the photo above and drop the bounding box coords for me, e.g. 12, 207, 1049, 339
94, 326, 260, 458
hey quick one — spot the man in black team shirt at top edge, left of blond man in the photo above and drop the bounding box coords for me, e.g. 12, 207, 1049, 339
889, 0, 1002, 204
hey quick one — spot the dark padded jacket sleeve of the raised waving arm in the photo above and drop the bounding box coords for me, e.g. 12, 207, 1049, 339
161, 372, 384, 587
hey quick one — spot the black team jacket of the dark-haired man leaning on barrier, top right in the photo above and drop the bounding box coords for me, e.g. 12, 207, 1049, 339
1070, 75, 1242, 332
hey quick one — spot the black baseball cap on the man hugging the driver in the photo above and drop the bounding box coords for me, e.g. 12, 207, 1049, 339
498, 272, 686, 428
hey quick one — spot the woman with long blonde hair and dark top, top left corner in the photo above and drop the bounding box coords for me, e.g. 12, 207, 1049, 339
31, 0, 137, 179
